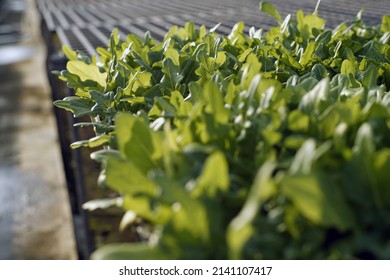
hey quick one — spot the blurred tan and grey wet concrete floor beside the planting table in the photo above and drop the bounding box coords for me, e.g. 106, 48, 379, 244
0, 0, 76, 259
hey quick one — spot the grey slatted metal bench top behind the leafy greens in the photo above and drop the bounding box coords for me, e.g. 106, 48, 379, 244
37, 0, 390, 54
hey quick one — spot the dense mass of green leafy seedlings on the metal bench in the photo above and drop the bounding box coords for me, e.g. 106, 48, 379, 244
55, 2, 390, 259
